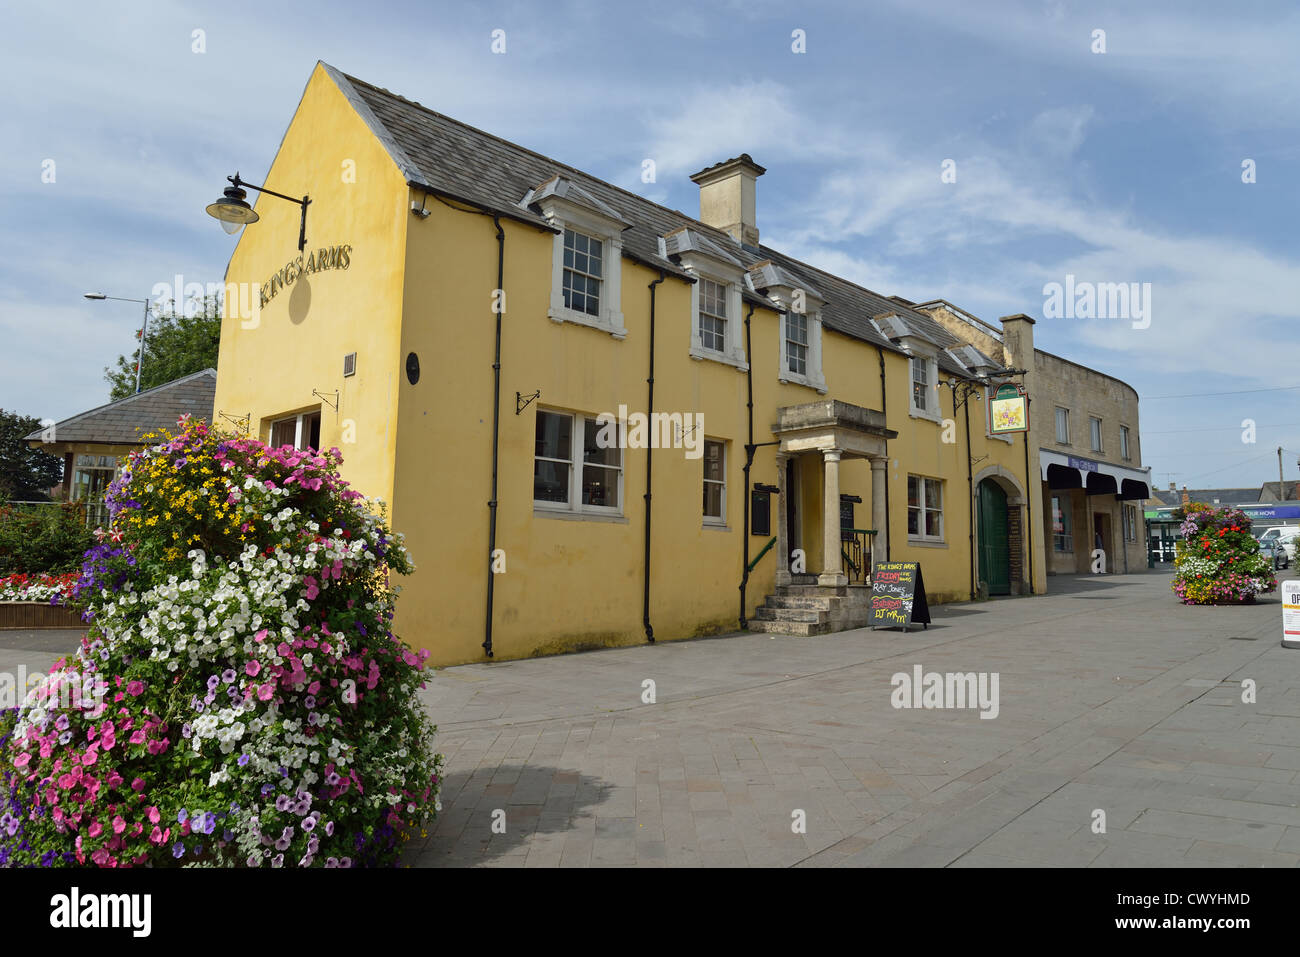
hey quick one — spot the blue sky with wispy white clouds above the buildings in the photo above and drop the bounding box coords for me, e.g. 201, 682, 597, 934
0, 0, 1300, 489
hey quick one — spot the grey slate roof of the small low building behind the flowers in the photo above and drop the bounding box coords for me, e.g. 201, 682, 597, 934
25, 369, 217, 445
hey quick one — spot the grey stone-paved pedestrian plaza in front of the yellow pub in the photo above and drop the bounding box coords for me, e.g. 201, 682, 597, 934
0, 572, 1300, 867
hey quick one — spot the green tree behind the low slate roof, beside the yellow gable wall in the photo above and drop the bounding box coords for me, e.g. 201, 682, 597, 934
104, 295, 221, 402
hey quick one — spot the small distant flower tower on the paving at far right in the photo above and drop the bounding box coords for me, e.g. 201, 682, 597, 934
1171, 502, 1278, 605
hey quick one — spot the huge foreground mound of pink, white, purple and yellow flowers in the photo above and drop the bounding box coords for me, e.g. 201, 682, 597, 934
0, 420, 442, 867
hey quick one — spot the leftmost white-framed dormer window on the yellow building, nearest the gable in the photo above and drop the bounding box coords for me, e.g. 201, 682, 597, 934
520, 176, 629, 339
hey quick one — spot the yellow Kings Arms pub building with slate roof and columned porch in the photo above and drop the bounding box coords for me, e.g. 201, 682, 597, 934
215, 64, 1047, 664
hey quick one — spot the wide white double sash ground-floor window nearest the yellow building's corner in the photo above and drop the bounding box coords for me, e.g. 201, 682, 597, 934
533, 410, 623, 515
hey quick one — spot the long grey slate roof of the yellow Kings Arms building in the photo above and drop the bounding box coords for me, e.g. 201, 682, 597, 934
321, 64, 1001, 376
